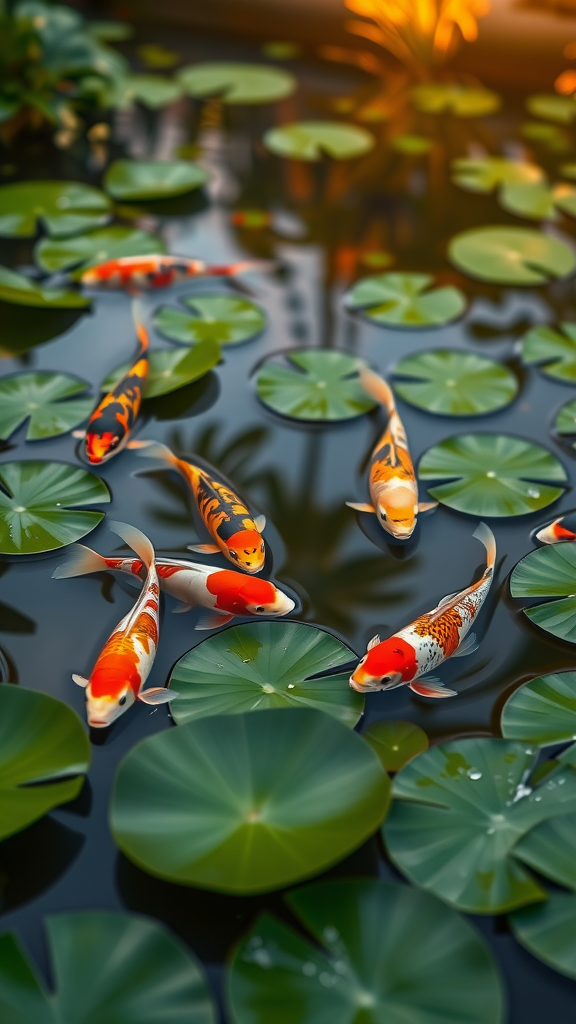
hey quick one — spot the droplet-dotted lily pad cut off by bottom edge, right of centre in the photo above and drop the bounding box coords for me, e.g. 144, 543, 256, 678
228, 879, 504, 1024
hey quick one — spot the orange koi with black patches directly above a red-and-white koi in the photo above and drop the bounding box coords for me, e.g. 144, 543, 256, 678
128, 441, 266, 572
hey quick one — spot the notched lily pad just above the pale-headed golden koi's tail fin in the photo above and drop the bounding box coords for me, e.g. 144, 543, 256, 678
344, 273, 466, 328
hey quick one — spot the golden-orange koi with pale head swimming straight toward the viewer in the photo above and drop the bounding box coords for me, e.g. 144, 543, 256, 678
346, 367, 438, 541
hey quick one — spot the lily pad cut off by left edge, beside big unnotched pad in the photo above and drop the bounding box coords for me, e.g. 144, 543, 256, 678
0, 684, 90, 839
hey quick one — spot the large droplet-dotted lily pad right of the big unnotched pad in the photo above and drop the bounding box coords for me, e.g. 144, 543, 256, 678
383, 738, 576, 913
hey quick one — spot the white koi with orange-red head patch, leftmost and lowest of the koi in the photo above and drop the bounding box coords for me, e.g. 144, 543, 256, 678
72, 522, 178, 729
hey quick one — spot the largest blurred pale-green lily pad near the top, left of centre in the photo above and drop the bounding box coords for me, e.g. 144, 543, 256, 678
176, 60, 297, 104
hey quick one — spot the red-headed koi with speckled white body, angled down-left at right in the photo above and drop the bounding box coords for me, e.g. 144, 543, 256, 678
349, 522, 496, 697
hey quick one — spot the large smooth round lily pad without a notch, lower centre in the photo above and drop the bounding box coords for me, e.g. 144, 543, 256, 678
110, 708, 387, 895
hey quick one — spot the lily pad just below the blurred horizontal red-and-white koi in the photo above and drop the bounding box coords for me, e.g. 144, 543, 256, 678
154, 295, 266, 345
